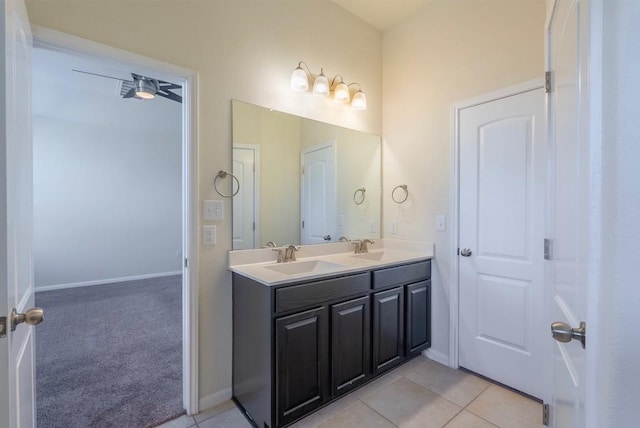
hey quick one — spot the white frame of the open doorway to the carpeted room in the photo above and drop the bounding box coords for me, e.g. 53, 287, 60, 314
32, 25, 199, 415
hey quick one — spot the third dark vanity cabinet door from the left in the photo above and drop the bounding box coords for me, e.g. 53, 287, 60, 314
373, 287, 404, 374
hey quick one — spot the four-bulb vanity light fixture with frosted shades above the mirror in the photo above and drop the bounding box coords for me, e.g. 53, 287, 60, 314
289, 61, 367, 110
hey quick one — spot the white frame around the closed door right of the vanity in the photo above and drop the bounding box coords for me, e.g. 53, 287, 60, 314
449, 79, 547, 372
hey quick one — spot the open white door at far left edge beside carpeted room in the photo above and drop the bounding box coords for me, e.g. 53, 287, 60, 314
0, 0, 35, 428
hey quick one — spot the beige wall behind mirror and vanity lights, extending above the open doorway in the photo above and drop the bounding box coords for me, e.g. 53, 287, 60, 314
27, 0, 382, 399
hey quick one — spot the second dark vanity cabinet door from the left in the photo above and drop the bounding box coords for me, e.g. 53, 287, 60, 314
331, 296, 371, 396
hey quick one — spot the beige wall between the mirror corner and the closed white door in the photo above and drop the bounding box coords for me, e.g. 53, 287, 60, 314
383, 0, 545, 358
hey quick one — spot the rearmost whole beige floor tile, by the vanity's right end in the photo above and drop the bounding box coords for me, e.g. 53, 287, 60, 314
405, 361, 491, 407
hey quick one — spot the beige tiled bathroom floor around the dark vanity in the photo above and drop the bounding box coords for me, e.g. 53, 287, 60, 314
159, 357, 542, 428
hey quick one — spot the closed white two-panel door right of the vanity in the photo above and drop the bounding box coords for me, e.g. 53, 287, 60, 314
459, 89, 546, 397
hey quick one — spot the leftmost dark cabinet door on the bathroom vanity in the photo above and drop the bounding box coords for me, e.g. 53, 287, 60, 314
276, 307, 329, 426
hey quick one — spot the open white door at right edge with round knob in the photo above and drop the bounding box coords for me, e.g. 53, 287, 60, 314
547, 0, 590, 428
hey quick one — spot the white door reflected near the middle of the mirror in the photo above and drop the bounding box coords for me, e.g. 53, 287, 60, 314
300, 142, 337, 244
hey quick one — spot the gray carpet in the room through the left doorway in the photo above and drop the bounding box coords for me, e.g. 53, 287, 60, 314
36, 276, 183, 428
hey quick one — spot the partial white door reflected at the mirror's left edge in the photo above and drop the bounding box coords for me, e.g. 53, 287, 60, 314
233, 144, 260, 250
